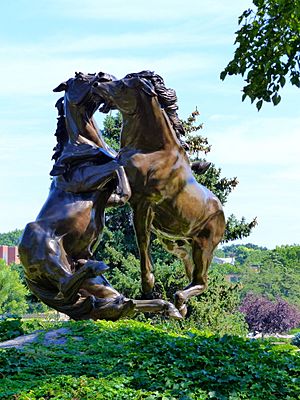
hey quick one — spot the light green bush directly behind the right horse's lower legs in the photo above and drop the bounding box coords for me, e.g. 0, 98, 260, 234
99, 246, 247, 336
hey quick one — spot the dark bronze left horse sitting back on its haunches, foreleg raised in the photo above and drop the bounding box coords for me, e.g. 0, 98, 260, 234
19, 73, 180, 320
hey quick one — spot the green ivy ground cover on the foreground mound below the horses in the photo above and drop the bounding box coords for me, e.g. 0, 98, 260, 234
0, 321, 300, 400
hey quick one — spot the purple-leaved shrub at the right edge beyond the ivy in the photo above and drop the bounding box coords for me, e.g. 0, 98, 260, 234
240, 294, 300, 334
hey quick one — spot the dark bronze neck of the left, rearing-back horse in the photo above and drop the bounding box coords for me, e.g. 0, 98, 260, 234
65, 99, 107, 149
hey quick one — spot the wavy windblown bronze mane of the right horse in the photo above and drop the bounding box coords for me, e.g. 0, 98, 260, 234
125, 70, 185, 139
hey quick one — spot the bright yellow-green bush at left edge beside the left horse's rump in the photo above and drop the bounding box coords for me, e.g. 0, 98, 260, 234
0, 259, 28, 315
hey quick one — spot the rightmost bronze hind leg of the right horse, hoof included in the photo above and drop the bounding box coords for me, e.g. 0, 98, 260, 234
175, 213, 225, 316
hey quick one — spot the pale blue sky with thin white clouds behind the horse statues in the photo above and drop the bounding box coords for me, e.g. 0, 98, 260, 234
0, 0, 300, 248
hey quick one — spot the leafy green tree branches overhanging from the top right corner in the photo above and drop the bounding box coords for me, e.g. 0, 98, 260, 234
220, 0, 300, 110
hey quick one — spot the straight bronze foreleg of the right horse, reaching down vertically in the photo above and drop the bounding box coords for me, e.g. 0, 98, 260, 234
133, 204, 154, 298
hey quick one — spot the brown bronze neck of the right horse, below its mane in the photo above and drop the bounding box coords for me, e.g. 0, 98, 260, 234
121, 95, 181, 152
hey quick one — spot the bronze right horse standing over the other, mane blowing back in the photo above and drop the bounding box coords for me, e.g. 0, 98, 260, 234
93, 71, 225, 316
